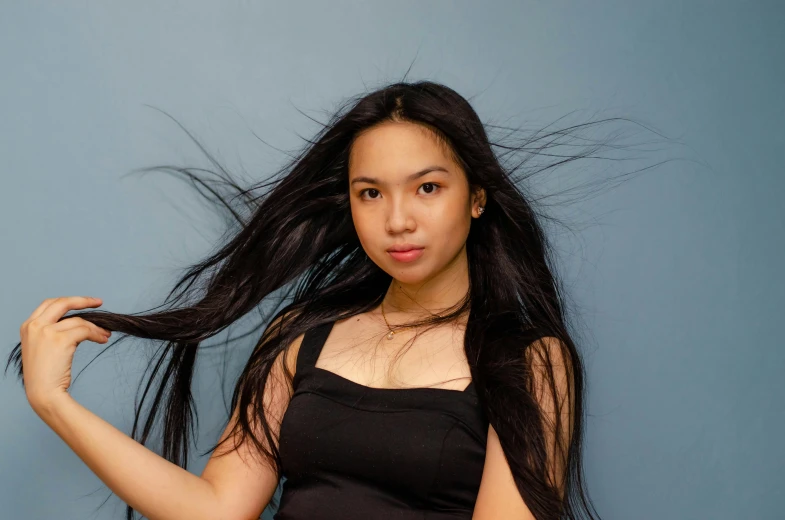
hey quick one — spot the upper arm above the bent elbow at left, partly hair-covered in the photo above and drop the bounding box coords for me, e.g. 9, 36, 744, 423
202, 335, 302, 520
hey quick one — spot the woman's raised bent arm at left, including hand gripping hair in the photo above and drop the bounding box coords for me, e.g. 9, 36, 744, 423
20, 297, 302, 520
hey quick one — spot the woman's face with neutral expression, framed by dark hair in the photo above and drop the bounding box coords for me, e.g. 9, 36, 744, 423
349, 122, 485, 284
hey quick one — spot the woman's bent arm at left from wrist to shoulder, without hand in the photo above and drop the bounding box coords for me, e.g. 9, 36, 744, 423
31, 336, 302, 520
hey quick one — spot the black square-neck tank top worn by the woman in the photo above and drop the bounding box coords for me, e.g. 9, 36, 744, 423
273, 322, 488, 520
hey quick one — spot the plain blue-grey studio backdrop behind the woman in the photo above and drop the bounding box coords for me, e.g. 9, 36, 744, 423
0, 0, 785, 520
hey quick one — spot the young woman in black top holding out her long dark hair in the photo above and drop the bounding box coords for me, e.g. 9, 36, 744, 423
9, 82, 612, 520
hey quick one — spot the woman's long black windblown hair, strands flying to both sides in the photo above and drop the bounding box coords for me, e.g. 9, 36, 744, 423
6, 77, 668, 520
